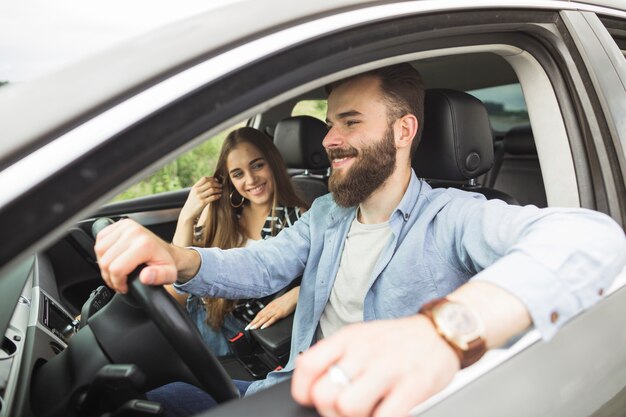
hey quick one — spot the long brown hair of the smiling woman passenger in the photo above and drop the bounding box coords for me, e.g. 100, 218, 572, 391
203, 127, 308, 329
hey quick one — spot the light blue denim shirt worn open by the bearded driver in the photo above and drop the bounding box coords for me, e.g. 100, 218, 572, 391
176, 173, 626, 394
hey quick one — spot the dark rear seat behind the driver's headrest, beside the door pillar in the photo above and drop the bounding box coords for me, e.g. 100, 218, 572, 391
491, 125, 547, 207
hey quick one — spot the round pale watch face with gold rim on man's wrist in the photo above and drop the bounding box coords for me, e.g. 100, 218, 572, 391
434, 302, 481, 347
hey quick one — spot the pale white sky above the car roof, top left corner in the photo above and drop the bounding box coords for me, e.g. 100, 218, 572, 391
0, 0, 235, 82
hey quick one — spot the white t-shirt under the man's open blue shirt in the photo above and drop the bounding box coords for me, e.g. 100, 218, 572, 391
318, 216, 391, 339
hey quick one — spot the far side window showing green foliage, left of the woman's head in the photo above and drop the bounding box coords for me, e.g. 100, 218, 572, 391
111, 122, 245, 202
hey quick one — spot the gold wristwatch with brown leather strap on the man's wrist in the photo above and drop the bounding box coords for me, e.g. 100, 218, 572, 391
419, 298, 487, 369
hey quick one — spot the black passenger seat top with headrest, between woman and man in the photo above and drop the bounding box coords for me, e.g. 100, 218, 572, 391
274, 116, 330, 205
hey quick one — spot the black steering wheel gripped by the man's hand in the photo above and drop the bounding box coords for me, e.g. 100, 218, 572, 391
88, 217, 240, 403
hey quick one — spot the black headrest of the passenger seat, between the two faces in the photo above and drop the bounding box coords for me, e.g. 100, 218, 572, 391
274, 116, 330, 170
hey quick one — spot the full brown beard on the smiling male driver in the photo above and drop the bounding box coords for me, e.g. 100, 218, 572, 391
328, 126, 396, 207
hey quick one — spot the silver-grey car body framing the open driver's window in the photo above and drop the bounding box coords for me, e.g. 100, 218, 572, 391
0, 0, 626, 417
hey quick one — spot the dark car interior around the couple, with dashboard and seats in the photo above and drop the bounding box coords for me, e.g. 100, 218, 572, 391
0, 11, 620, 417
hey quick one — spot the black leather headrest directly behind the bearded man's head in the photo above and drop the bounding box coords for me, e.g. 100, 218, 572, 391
412, 89, 493, 181
